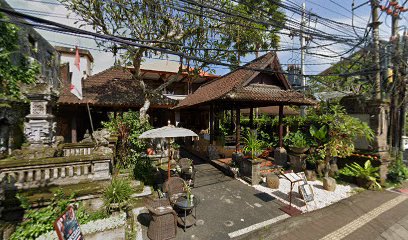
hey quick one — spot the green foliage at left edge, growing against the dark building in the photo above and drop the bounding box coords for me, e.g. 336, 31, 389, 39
0, 14, 40, 100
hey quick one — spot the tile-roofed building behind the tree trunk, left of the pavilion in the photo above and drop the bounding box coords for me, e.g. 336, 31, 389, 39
57, 60, 218, 142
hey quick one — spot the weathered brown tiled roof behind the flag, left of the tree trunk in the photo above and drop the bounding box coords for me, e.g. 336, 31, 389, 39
58, 67, 177, 107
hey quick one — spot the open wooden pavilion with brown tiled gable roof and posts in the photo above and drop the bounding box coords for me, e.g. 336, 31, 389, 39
175, 52, 315, 151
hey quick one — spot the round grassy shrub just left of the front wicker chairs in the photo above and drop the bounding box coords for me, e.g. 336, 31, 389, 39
103, 178, 133, 210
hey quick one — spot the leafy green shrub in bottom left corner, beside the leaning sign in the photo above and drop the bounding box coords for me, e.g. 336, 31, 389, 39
10, 189, 88, 240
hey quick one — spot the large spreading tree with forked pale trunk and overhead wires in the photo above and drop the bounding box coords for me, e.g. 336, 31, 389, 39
59, 0, 283, 121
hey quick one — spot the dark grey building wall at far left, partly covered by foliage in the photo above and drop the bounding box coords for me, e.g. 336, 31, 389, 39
0, 0, 60, 155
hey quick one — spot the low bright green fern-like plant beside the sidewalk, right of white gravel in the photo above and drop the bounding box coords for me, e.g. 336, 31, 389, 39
340, 160, 381, 189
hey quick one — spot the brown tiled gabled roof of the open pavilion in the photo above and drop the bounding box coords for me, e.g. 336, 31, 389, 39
176, 52, 314, 108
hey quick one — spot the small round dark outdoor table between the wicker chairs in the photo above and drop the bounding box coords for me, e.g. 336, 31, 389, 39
175, 195, 200, 232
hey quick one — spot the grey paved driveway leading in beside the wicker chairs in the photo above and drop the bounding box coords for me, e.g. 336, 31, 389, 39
176, 153, 287, 240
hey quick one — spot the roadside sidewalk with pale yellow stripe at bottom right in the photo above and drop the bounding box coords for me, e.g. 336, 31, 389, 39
237, 188, 408, 240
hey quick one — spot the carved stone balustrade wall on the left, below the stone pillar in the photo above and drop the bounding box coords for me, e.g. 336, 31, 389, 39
0, 154, 112, 190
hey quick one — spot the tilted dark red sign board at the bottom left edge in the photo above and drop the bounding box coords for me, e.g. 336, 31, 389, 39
54, 206, 84, 240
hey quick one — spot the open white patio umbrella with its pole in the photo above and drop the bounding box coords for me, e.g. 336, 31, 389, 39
139, 126, 198, 178
